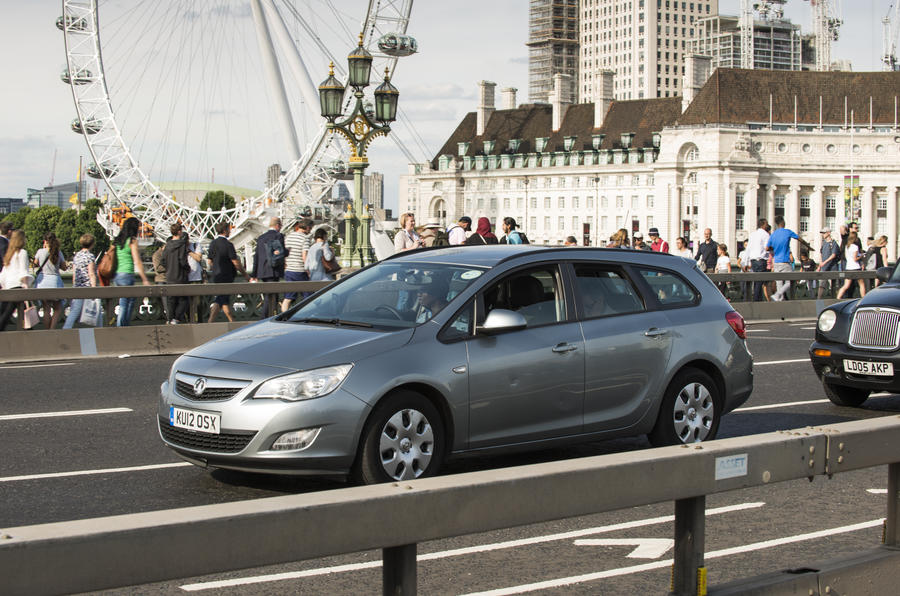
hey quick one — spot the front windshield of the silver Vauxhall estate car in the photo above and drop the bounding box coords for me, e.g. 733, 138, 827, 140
281, 262, 486, 329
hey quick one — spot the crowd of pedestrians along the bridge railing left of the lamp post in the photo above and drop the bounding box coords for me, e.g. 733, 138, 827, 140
0, 217, 340, 331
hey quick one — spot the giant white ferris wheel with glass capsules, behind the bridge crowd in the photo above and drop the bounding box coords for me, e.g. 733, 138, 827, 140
57, 0, 415, 243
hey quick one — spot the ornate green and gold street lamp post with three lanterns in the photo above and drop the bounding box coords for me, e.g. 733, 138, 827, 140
319, 34, 400, 267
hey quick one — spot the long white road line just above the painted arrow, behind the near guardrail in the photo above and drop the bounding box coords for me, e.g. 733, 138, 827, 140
180, 502, 765, 592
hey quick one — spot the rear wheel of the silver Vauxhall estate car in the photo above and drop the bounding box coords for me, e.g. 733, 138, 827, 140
647, 368, 722, 447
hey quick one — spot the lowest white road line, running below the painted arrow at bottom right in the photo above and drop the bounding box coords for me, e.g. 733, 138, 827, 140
465, 518, 884, 596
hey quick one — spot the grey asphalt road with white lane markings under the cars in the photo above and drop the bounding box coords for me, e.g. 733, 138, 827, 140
0, 323, 900, 595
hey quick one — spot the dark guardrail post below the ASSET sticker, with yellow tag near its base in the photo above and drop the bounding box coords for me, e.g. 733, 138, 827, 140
671, 495, 706, 596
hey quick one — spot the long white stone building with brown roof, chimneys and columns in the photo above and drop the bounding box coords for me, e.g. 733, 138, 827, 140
400, 66, 900, 260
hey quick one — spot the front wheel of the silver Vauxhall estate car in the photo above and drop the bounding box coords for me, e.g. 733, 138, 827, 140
352, 391, 446, 484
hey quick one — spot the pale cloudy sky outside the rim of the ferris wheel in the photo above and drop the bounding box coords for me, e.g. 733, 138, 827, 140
0, 0, 892, 212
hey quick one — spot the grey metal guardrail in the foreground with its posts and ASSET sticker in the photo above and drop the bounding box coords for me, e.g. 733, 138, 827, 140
0, 416, 900, 596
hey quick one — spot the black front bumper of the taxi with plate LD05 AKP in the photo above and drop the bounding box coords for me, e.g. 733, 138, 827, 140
809, 341, 900, 393
